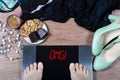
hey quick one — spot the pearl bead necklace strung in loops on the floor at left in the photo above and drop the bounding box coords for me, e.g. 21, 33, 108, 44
0, 21, 22, 61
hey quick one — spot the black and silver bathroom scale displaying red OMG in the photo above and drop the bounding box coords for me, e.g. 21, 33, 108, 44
22, 46, 93, 80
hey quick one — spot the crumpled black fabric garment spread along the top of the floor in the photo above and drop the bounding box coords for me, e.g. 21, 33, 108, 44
19, 0, 120, 31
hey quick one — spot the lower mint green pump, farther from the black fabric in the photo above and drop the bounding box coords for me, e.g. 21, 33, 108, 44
93, 36, 120, 71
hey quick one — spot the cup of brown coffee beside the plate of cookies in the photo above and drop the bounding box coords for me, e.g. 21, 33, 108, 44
7, 14, 21, 29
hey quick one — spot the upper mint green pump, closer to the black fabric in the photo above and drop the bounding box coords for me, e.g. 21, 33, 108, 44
92, 19, 120, 56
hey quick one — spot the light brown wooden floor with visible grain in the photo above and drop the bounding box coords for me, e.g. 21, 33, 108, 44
0, 8, 120, 80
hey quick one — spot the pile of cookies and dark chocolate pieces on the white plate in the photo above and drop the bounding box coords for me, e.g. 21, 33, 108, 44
20, 19, 48, 42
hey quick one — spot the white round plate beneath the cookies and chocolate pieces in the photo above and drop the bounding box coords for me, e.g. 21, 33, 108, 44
24, 23, 48, 44
